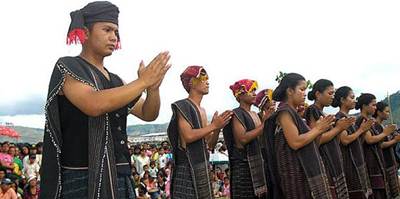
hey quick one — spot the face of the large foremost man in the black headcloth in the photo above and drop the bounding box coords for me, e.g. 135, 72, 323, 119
84, 22, 119, 57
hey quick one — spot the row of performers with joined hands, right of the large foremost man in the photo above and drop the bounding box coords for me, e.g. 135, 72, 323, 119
168, 66, 400, 199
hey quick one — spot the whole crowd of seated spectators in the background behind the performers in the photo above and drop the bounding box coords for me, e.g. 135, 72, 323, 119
0, 141, 230, 199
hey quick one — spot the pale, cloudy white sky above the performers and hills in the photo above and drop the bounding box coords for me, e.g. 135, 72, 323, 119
0, 0, 400, 127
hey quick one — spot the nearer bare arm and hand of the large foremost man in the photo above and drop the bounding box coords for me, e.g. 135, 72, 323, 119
62, 53, 169, 117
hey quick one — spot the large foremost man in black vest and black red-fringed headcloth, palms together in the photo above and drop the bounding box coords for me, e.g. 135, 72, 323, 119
40, 1, 170, 199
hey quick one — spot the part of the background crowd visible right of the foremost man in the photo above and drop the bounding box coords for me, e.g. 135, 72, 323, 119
130, 141, 230, 199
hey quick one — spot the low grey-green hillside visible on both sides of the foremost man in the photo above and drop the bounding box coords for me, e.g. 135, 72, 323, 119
0, 123, 168, 143
